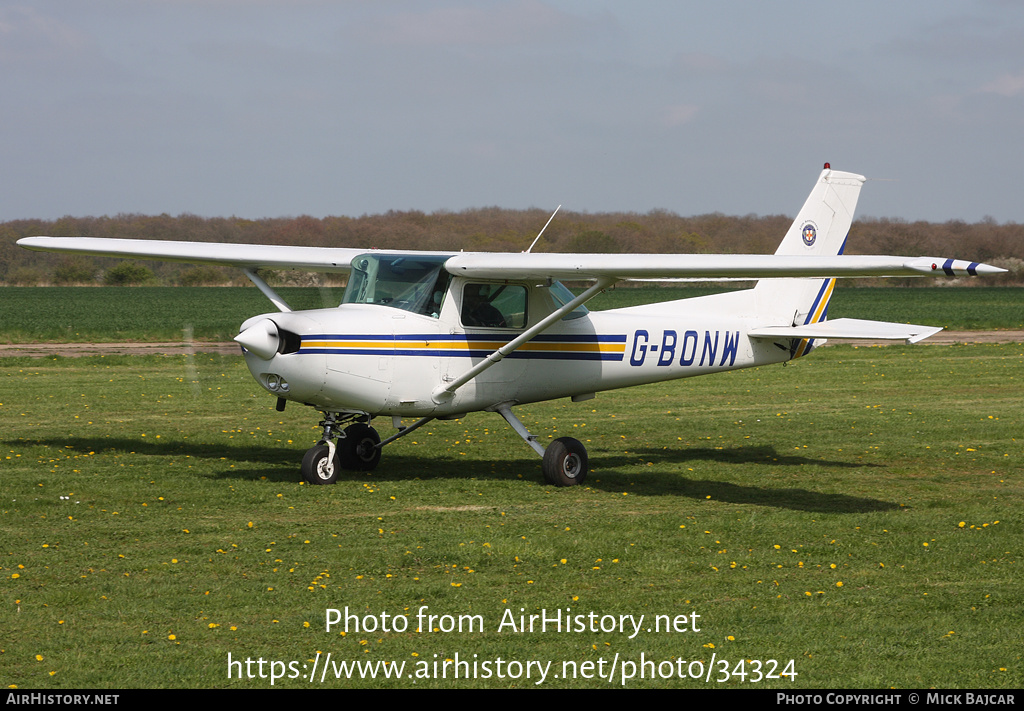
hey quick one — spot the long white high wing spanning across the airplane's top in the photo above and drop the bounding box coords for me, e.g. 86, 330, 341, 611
17, 237, 1005, 281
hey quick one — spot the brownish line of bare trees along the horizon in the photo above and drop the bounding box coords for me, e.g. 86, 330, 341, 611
0, 207, 1024, 286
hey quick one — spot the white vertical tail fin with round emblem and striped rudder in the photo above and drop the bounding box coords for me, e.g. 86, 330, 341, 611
755, 163, 866, 358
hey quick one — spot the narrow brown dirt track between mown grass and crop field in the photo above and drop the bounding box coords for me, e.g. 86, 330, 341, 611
0, 331, 1024, 358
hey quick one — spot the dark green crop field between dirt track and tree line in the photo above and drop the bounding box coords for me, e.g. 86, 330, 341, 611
0, 285, 1024, 343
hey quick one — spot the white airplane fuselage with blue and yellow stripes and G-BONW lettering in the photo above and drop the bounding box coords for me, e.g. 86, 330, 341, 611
237, 279, 792, 417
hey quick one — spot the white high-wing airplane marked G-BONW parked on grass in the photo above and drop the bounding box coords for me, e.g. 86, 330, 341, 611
18, 163, 1005, 487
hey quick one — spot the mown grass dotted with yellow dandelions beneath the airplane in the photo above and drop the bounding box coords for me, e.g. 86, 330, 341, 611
0, 344, 1024, 688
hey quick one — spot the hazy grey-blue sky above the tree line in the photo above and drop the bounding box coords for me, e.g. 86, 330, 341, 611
0, 0, 1024, 222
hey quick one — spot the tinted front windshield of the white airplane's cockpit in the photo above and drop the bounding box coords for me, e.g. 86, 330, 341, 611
341, 253, 452, 319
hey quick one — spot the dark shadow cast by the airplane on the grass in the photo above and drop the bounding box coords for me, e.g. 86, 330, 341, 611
14, 437, 900, 513
